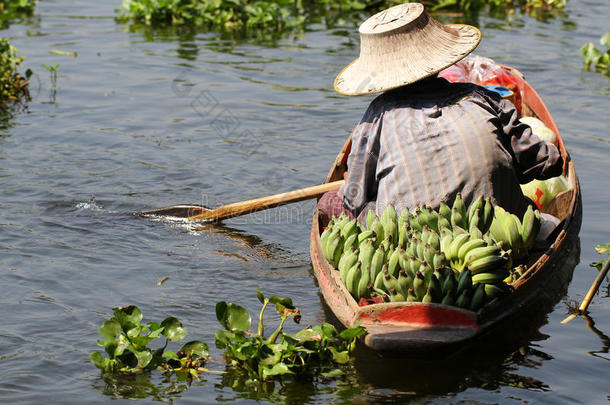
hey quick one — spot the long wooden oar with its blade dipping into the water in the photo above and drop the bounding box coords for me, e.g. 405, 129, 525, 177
140, 180, 344, 222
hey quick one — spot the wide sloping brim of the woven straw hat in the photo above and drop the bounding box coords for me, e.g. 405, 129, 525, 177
334, 24, 481, 96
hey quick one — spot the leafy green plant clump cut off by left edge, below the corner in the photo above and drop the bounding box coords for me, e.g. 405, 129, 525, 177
0, 38, 32, 110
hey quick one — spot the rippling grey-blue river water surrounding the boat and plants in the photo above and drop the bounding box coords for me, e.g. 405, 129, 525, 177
0, 0, 610, 404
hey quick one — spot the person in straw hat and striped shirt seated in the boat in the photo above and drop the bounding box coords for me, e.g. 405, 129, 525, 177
318, 3, 563, 223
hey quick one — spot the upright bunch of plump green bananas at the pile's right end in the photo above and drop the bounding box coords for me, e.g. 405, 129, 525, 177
489, 206, 541, 260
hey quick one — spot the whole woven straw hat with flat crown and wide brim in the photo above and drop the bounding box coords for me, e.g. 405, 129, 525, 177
334, 3, 481, 96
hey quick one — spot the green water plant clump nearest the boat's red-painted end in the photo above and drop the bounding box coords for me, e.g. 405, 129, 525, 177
216, 290, 365, 381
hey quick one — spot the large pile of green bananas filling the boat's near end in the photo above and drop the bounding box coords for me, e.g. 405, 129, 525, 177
320, 200, 512, 311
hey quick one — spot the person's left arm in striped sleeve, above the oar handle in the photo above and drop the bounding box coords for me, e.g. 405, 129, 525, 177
339, 103, 381, 217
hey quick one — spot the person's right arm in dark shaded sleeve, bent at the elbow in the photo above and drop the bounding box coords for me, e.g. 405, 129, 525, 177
498, 100, 563, 184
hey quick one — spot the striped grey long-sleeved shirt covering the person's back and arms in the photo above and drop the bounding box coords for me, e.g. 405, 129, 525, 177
340, 78, 561, 221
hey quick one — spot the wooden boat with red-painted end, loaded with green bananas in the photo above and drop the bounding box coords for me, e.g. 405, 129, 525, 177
310, 67, 582, 353
